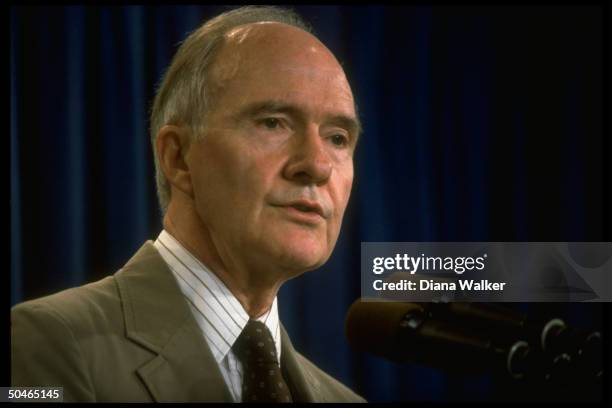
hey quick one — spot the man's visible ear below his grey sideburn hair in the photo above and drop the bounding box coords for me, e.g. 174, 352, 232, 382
155, 125, 193, 197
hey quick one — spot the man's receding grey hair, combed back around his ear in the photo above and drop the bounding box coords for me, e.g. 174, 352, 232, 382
150, 6, 312, 214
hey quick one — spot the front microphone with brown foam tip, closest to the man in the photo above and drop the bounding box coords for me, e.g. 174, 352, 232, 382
345, 300, 530, 375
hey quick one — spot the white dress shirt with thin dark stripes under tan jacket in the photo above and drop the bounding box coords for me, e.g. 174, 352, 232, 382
154, 230, 281, 402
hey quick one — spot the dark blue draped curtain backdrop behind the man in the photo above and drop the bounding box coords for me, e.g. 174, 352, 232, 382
10, 6, 610, 401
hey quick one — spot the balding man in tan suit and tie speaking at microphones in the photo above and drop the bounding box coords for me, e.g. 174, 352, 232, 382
12, 7, 363, 402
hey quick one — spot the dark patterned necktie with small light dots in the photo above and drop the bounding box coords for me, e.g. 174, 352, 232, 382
233, 320, 292, 402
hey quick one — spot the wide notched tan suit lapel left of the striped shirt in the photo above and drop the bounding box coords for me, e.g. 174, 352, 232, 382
115, 241, 232, 402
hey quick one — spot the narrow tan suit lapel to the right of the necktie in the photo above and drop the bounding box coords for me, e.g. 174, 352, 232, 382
280, 324, 320, 402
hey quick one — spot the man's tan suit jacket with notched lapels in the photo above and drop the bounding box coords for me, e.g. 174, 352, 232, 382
11, 241, 364, 402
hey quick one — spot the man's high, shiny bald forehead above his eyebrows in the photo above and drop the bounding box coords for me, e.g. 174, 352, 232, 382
211, 23, 355, 116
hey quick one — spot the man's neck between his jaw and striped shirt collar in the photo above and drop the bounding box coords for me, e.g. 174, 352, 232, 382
163, 199, 283, 319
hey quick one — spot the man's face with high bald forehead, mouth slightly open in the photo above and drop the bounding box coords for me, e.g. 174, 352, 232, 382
188, 23, 357, 278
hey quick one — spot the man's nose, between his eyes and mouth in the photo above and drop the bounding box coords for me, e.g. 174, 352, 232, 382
283, 128, 332, 185
